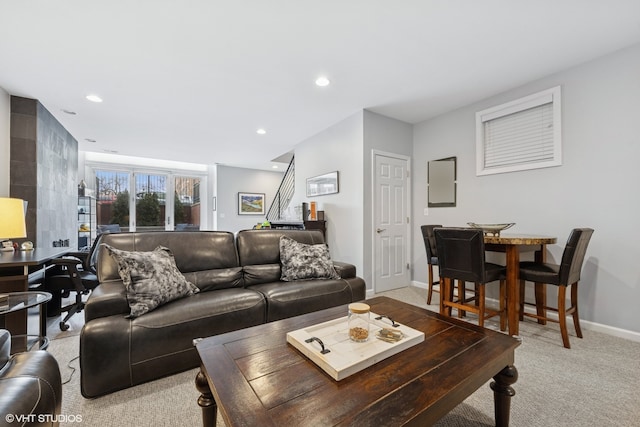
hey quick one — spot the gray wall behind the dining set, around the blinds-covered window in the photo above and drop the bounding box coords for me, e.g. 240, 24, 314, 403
413, 46, 640, 332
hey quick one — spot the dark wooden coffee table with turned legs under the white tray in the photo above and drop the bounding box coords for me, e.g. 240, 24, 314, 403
195, 297, 520, 427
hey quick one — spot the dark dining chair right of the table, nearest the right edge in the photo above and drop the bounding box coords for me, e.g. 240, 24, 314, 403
520, 228, 593, 348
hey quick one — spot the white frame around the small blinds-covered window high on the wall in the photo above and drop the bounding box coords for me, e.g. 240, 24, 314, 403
476, 86, 562, 176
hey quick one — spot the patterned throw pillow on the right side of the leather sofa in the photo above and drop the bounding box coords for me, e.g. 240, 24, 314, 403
280, 236, 340, 282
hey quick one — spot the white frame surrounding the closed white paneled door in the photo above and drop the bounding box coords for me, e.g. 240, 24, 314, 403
369, 149, 413, 294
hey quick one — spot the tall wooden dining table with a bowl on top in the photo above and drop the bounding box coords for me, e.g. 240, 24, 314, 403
484, 234, 557, 336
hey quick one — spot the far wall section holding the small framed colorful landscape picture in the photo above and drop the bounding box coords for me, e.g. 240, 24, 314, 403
214, 165, 284, 232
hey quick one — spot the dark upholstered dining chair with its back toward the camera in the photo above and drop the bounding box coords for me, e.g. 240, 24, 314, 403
434, 228, 507, 331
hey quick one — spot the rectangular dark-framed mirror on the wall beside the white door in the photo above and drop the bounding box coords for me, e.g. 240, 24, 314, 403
427, 157, 456, 208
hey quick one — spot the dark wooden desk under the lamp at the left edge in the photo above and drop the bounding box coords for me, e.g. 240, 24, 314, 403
0, 248, 70, 353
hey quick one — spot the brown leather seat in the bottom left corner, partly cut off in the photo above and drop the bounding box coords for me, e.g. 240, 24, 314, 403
0, 329, 62, 426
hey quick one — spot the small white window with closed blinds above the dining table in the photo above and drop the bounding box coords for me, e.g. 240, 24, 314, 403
476, 86, 562, 175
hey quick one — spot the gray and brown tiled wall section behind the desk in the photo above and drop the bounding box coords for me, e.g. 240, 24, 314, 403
10, 96, 78, 247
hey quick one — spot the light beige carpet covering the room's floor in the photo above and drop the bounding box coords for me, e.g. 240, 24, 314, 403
49, 287, 640, 427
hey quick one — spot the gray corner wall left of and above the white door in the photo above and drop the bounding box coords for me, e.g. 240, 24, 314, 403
292, 110, 413, 291
